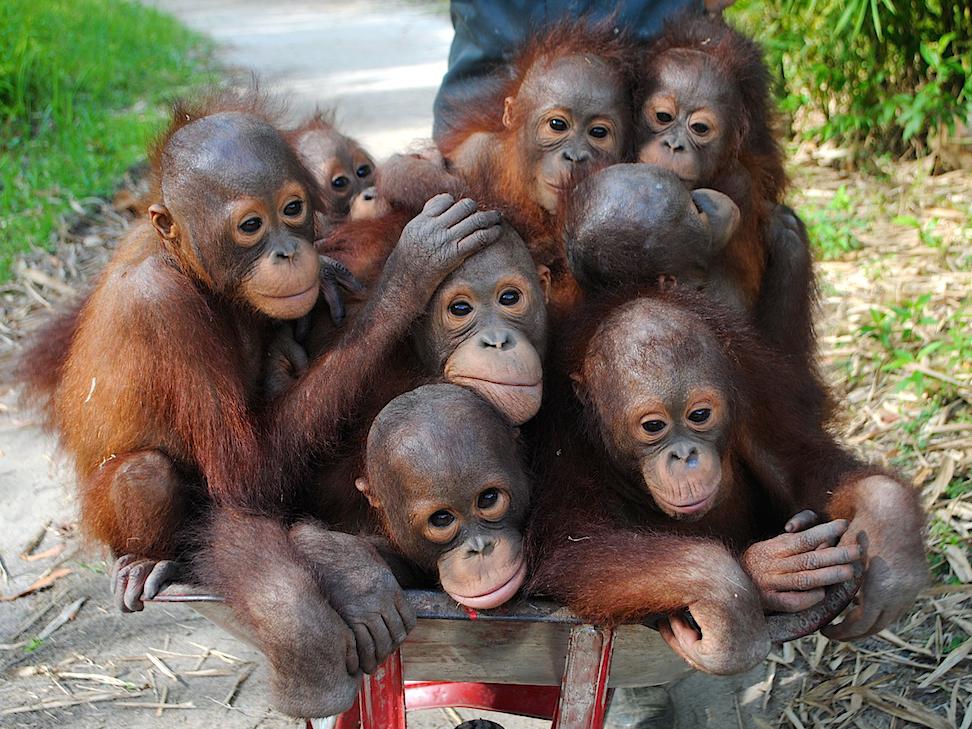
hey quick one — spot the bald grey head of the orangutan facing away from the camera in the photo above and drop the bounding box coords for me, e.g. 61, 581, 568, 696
564, 164, 739, 290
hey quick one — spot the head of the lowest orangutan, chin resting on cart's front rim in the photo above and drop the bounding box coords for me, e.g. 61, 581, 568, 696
356, 384, 530, 609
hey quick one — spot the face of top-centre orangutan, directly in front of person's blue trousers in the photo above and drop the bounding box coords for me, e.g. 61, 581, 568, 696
503, 56, 629, 213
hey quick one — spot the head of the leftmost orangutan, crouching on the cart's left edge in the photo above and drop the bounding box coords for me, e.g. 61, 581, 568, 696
149, 112, 320, 319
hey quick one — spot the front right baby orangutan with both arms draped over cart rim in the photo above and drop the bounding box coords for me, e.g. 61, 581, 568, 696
531, 297, 924, 673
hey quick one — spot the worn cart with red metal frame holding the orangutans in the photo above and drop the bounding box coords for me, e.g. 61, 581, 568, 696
157, 590, 689, 729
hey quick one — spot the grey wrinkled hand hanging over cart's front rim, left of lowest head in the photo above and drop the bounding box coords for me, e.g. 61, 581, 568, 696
290, 522, 415, 674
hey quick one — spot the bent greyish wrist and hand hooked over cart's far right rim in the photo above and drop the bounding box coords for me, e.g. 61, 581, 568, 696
821, 476, 929, 640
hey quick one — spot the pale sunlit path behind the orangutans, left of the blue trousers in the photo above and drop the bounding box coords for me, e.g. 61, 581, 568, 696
149, 0, 452, 159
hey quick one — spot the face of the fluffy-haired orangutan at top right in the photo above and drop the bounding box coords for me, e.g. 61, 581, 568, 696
638, 49, 740, 187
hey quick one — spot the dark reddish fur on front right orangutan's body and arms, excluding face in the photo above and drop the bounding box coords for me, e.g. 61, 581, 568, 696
531, 295, 920, 623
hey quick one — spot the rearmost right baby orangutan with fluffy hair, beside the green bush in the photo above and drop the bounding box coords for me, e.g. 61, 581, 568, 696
635, 15, 814, 358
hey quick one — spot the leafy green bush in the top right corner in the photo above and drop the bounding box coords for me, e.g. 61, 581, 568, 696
730, 0, 972, 163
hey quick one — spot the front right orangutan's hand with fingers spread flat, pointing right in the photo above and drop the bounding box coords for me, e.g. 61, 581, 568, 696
740, 511, 863, 613
